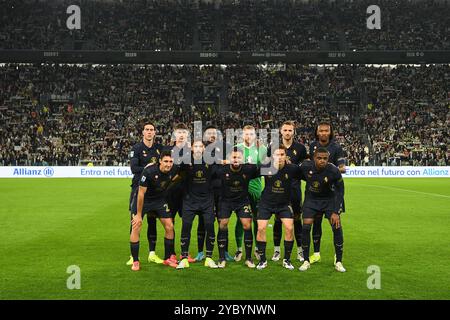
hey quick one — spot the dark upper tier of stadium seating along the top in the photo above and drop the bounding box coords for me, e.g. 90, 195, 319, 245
0, 0, 450, 51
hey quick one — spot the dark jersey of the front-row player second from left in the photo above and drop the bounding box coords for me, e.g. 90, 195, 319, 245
180, 160, 218, 202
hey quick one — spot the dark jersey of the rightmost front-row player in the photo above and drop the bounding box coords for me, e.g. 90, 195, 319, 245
300, 160, 344, 212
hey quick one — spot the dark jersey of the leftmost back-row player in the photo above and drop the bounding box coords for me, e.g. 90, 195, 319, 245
130, 141, 163, 188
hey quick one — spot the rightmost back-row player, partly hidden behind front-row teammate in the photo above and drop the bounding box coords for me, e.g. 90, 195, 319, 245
309, 121, 345, 263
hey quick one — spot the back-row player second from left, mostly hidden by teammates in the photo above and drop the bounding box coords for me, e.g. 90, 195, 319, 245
165, 122, 195, 262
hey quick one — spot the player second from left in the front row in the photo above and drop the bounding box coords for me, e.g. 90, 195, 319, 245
177, 140, 217, 269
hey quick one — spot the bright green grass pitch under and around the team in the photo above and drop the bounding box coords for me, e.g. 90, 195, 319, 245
0, 179, 450, 299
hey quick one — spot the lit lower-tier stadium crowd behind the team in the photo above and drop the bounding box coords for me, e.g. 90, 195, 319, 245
0, 64, 450, 165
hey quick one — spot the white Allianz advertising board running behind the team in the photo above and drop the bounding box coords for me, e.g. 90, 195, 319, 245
0, 166, 450, 178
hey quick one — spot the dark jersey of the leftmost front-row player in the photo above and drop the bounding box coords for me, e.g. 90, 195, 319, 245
139, 165, 179, 202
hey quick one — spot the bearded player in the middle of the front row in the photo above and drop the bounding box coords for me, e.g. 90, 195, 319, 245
217, 148, 259, 268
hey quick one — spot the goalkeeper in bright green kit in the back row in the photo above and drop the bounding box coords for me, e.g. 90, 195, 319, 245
234, 125, 267, 261
